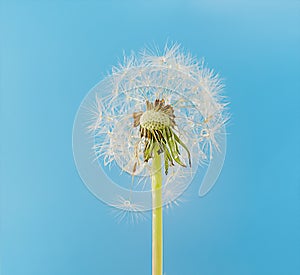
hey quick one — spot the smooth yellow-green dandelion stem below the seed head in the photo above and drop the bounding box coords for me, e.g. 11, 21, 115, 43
152, 144, 163, 275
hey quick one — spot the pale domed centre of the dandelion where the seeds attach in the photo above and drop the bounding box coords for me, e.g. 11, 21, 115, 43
140, 110, 171, 130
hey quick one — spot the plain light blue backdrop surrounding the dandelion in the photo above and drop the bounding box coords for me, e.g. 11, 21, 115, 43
0, 0, 300, 275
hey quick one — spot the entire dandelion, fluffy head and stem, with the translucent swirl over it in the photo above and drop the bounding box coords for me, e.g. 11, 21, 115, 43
73, 44, 228, 275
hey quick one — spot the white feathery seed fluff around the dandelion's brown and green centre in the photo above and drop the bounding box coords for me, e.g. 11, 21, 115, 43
85, 44, 228, 211
